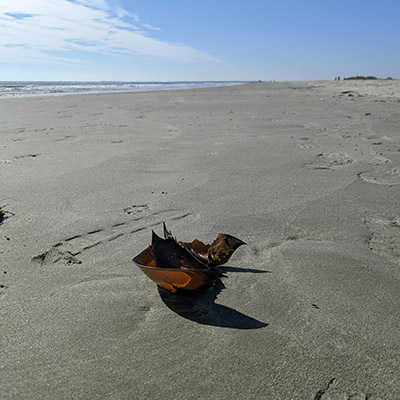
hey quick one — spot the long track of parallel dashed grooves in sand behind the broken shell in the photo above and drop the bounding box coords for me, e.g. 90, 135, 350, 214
32, 204, 192, 265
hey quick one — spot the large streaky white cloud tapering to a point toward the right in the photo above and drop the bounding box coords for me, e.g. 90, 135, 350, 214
0, 0, 215, 63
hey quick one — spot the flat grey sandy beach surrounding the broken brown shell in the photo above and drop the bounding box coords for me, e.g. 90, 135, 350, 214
0, 81, 400, 400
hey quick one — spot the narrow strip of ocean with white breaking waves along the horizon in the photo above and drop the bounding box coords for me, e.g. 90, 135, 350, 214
0, 81, 247, 99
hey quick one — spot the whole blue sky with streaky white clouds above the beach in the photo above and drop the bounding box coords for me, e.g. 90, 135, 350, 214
0, 0, 400, 81
